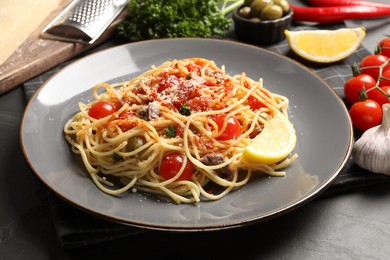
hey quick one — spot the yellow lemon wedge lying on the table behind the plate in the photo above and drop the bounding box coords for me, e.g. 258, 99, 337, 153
284, 27, 366, 63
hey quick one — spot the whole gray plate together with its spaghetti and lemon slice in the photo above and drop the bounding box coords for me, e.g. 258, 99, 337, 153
21, 39, 353, 231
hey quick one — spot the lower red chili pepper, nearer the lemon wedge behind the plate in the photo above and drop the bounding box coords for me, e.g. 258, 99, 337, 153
290, 4, 390, 23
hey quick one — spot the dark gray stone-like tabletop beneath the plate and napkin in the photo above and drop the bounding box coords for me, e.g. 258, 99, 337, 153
0, 0, 390, 259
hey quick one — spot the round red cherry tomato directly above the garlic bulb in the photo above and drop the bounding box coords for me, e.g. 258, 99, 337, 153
349, 99, 382, 131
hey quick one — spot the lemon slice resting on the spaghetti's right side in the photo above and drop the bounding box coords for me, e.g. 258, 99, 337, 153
242, 113, 297, 164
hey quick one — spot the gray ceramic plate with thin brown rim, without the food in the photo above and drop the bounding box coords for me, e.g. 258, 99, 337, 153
21, 39, 353, 231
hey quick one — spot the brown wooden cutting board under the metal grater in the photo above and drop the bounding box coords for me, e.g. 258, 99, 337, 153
0, 0, 128, 94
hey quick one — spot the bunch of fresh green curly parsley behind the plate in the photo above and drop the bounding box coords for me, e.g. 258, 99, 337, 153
118, 0, 241, 41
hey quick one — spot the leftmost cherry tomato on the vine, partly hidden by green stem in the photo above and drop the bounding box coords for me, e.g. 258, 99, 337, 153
344, 74, 376, 104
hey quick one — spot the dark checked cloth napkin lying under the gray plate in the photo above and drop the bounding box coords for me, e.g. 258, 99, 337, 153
24, 24, 390, 248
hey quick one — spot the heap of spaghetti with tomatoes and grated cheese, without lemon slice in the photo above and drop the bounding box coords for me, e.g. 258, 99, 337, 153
64, 58, 297, 203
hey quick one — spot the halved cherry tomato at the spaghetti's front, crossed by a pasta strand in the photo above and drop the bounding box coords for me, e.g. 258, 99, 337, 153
160, 152, 194, 181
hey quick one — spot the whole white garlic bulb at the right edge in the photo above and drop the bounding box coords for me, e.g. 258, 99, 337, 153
352, 104, 390, 175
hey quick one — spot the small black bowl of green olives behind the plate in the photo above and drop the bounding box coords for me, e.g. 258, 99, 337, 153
233, 0, 293, 45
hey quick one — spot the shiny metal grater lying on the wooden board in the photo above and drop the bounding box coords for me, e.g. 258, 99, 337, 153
41, 0, 128, 44
